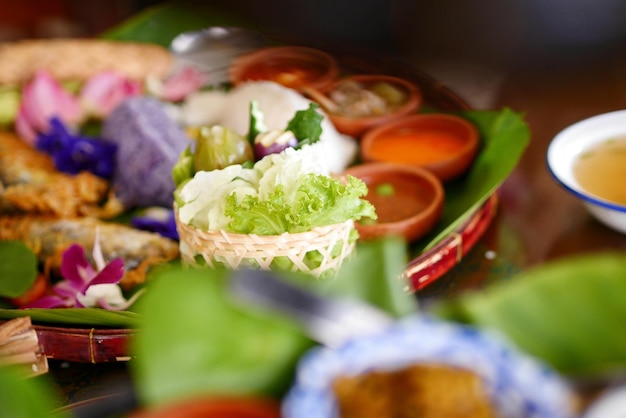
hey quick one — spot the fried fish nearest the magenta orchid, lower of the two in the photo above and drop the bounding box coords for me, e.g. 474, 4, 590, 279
0, 216, 179, 289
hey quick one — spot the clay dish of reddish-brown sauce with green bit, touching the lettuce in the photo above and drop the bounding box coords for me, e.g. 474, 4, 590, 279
344, 163, 444, 242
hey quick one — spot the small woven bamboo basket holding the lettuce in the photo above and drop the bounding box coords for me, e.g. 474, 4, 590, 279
176, 216, 355, 277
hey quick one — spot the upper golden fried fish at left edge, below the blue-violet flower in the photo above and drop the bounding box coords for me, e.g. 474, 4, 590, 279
0, 132, 124, 218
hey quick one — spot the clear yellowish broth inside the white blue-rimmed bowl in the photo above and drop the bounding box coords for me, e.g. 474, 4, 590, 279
574, 136, 626, 205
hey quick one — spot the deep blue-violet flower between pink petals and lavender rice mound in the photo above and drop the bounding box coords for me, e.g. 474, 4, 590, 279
36, 117, 117, 179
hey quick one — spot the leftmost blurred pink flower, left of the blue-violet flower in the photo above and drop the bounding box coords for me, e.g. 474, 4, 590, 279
15, 70, 82, 145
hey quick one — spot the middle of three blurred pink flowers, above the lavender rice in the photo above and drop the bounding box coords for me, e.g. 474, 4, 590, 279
79, 71, 141, 118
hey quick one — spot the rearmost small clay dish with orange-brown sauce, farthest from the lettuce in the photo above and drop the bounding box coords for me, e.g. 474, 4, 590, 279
229, 46, 339, 91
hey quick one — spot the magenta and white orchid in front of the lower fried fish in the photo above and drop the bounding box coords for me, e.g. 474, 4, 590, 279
26, 231, 141, 310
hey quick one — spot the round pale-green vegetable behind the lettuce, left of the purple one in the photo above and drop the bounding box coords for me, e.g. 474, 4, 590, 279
193, 125, 254, 172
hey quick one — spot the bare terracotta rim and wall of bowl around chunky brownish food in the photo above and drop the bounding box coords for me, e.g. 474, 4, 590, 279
320, 74, 422, 137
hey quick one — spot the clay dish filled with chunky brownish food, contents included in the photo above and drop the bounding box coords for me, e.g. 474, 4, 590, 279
314, 74, 422, 137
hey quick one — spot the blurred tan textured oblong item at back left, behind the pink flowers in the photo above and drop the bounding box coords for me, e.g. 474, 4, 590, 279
0, 38, 174, 84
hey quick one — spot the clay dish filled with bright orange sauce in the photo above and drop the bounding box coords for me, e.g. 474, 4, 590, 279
360, 113, 480, 182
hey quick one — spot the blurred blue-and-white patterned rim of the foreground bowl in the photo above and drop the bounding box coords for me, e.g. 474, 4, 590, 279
282, 316, 575, 418
